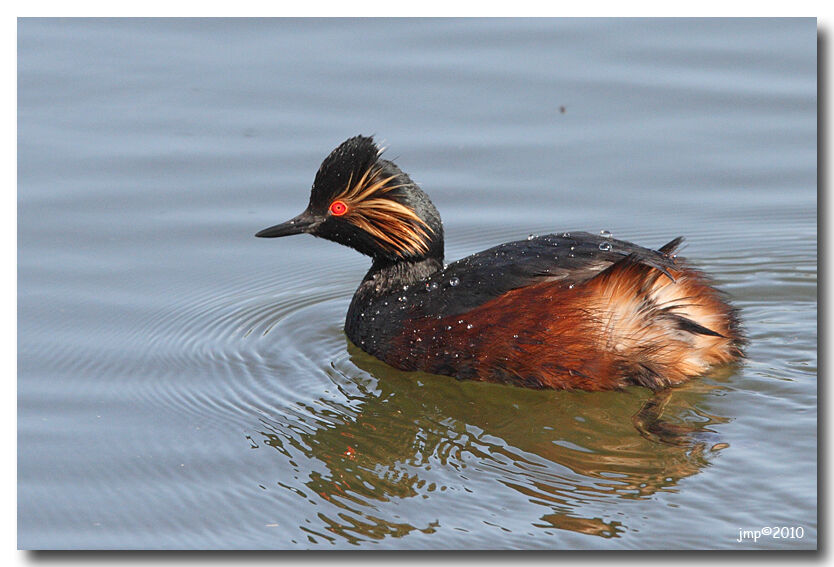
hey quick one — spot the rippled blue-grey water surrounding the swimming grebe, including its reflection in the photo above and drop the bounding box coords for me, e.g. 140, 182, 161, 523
18, 19, 817, 549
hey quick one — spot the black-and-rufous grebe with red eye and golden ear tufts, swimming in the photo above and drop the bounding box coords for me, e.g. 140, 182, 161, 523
256, 136, 744, 390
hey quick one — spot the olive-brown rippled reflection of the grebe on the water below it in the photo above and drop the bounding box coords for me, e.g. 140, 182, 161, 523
250, 345, 728, 543
